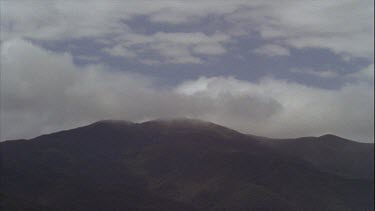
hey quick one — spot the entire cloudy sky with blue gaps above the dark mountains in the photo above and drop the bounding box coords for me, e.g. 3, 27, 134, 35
0, 0, 374, 142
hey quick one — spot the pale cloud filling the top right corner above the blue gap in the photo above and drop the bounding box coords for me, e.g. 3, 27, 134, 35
226, 0, 374, 59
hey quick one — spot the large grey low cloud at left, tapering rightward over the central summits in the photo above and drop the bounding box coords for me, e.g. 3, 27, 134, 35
1, 39, 275, 140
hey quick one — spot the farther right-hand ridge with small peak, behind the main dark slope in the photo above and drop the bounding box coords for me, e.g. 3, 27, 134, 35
262, 134, 374, 179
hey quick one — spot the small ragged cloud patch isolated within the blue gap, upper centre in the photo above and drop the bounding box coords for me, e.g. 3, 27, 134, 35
104, 32, 231, 64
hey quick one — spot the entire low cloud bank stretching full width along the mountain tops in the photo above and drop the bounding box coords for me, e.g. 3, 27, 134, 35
1, 39, 374, 141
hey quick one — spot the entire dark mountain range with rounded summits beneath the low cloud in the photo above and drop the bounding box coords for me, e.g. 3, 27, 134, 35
0, 119, 374, 211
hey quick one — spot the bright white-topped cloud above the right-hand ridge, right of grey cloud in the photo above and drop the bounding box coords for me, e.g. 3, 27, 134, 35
177, 77, 374, 141
